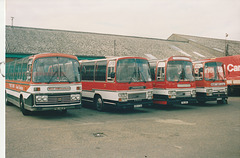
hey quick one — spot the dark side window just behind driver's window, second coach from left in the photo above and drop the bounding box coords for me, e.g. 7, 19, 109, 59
95, 61, 107, 81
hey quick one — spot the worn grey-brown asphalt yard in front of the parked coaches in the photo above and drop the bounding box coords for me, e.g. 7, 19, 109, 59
6, 97, 240, 158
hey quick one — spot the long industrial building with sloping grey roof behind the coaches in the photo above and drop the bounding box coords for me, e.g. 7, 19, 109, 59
6, 26, 240, 62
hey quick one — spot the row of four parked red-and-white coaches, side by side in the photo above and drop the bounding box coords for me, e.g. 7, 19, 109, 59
6, 53, 227, 115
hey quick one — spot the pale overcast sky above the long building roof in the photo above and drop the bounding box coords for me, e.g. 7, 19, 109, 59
3, 0, 240, 41
